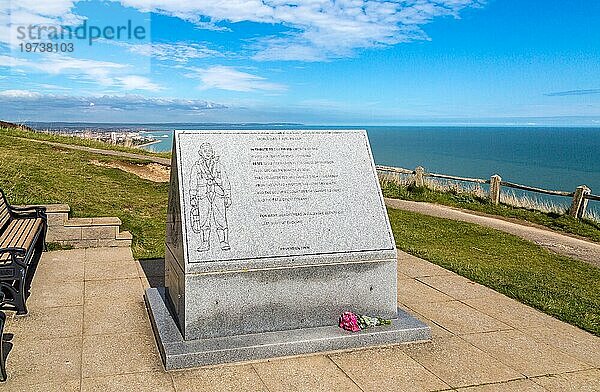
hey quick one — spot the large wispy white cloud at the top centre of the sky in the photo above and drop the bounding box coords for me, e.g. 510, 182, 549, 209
115, 0, 486, 61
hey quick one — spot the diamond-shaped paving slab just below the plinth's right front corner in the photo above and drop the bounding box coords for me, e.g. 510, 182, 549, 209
403, 336, 523, 388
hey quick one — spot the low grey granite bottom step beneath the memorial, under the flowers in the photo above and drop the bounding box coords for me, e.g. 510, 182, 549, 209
145, 288, 431, 370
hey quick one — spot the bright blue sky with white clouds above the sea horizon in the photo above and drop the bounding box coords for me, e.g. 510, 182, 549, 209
0, 0, 600, 126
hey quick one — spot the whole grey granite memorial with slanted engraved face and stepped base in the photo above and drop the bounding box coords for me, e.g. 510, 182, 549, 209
146, 130, 431, 369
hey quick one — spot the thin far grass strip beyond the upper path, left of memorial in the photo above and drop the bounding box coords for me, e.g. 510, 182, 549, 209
0, 127, 171, 158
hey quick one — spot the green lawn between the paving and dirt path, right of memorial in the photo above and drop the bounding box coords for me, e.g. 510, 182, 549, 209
388, 209, 600, 336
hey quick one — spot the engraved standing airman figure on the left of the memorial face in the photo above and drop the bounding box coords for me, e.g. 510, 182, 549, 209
190, 143, 231, 252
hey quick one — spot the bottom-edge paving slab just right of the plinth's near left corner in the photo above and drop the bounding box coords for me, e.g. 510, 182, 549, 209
172, 364, 268, 392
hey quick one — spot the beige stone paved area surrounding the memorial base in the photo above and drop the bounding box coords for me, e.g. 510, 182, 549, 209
0, 248, 600, 392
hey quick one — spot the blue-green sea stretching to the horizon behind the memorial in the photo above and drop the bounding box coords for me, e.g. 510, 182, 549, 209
28, 123, 600, 216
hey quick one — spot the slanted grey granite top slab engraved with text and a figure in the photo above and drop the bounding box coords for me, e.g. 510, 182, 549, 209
167, 130, 395, 273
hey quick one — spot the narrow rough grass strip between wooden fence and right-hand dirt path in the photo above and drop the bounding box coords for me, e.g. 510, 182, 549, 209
382, 181, 600, 242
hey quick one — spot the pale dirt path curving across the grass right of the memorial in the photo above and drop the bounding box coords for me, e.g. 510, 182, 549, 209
385, 198, 600, 267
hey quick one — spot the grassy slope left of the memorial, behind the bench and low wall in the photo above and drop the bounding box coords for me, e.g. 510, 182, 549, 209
0, 134, 168, 258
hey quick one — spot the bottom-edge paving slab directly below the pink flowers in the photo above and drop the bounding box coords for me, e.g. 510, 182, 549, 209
329, 347, 450, 392
